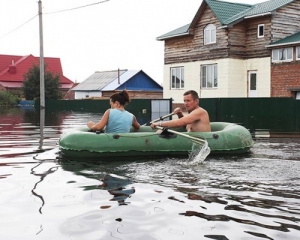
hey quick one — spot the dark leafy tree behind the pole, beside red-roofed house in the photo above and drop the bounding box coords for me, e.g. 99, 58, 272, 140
23, 65, 62, 100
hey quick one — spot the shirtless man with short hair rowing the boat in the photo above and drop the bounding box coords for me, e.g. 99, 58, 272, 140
151, 90, 211, 132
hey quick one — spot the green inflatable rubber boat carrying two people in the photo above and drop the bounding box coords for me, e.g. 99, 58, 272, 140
59, 122, 253, 158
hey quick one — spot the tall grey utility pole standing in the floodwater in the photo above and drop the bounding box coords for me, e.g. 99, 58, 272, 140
38, 0, 45, 108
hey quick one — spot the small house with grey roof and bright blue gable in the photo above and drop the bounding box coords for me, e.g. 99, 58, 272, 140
72, 69, 163, 99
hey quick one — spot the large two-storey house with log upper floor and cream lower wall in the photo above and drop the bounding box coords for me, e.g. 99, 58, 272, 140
157, 0, 300, 103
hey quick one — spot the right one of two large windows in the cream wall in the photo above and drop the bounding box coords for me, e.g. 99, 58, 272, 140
200, 64, 218, 88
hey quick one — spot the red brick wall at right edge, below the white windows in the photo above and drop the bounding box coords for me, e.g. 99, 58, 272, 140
271, 62, 300, 97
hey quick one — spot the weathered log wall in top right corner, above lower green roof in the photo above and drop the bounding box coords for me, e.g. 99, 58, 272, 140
271, 0, 300, 42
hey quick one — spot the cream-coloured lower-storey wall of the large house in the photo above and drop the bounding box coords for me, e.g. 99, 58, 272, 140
163, 57, 271, 104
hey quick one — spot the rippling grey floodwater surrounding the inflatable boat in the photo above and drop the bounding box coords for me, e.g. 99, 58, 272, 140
0, 108, 300, 240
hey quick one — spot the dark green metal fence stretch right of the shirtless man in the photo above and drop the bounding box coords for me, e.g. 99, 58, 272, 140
200, 98, 300, 133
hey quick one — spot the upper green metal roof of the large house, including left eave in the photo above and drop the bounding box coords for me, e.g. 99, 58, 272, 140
157, 0, 295, 40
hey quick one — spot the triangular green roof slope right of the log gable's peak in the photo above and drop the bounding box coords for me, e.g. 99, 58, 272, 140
205, 0, 253, 25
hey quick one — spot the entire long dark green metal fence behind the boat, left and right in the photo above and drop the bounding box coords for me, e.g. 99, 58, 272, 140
35, 98, 300, 133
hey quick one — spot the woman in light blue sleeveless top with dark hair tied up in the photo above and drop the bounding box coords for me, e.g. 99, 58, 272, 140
87, 90, 140, 133
